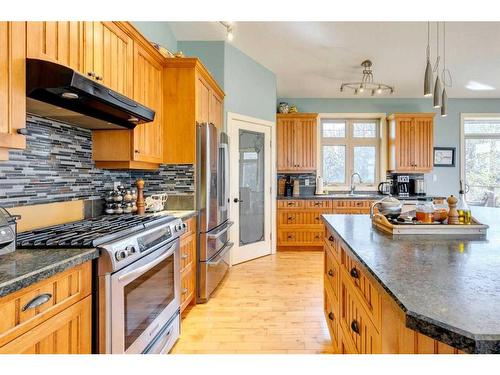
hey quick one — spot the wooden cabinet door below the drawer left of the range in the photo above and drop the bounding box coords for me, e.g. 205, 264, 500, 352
0, 296, 92, 354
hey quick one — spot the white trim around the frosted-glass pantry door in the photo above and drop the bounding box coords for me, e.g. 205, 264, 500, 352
227, 112, 277, 263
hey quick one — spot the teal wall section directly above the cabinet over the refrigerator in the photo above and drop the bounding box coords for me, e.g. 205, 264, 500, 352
177, 41, 225, 89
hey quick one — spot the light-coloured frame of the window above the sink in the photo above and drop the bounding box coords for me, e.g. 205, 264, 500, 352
316, 113, 387, 191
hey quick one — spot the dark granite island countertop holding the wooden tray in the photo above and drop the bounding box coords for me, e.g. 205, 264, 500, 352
323, 207, 500, 353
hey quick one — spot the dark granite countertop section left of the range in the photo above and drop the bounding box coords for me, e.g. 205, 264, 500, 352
0, 249, 99, 297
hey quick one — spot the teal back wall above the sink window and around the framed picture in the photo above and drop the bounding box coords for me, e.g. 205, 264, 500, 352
277, 98, 500, 195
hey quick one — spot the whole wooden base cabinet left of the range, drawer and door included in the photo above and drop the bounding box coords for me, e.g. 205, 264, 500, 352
0, 262, 92, 354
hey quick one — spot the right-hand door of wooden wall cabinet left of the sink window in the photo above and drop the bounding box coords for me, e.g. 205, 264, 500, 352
294, 118, 316, 171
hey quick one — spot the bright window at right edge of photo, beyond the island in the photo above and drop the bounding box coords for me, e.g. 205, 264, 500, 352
462, 114, 500, 207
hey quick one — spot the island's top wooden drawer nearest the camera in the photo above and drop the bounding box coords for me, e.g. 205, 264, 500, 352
340, 247, 382, 330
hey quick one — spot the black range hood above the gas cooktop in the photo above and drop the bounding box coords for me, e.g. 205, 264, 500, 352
26, 59, 155, 129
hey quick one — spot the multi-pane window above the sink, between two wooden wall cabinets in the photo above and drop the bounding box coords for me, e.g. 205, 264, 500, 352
320, 118, 380, 189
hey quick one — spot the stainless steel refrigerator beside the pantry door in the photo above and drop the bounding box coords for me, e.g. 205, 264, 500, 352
196, 123, 233, 303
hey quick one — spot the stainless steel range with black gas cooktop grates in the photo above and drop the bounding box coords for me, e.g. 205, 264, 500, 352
17, 215, 185, 354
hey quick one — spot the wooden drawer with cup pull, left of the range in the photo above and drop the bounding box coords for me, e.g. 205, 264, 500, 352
0, 262, 92, 347
